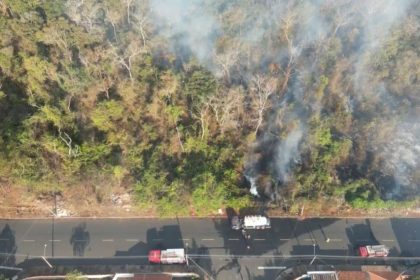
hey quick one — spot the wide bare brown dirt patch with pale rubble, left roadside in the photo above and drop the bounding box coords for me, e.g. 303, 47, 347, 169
0, 186, 156, 218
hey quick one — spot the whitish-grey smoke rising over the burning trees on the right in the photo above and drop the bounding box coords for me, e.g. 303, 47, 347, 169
151, 0, 420, 197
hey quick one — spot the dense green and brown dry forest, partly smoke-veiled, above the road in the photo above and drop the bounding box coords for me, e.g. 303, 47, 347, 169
0, 0, 420, 214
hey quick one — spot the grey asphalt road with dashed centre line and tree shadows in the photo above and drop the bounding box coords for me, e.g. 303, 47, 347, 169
0, 218, 420, 279
